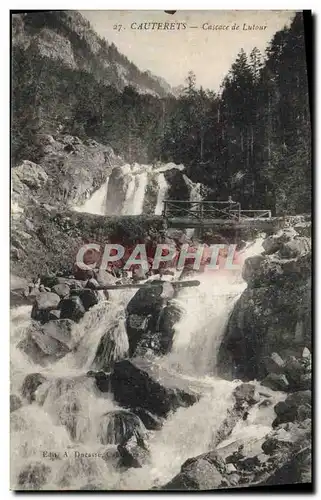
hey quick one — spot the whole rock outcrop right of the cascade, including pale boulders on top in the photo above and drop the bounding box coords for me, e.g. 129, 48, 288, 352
219, 228, 311, 380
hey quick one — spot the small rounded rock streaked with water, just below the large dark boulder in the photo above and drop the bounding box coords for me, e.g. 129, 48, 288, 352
99, 410, 147, 445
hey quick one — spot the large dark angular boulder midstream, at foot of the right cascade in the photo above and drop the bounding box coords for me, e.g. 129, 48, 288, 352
111, 358, 198, 417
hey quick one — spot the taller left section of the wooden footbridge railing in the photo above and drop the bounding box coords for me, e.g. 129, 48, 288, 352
163, 200, 241, 221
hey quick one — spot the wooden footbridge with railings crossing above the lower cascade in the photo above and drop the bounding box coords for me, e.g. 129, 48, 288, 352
162, 200, 274, 231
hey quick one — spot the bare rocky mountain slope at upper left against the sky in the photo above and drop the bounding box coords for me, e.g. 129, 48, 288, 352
12, 11, 173, 97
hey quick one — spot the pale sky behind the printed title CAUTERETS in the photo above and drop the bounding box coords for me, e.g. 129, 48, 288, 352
80, 10, 295, 91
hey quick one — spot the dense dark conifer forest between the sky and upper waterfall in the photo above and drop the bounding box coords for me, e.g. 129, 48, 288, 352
12, 14, 311, 214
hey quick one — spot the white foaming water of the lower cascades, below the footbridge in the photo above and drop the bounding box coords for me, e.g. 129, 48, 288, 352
11, 237, 274, 490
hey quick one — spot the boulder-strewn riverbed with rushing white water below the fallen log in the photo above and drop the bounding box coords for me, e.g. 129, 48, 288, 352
10, 222, 312, 490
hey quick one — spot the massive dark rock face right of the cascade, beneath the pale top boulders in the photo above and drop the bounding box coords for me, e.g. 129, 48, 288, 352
218, 279, 312, 380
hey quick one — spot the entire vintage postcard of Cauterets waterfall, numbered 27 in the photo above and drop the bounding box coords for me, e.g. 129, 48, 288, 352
10, 10, 312, 492
